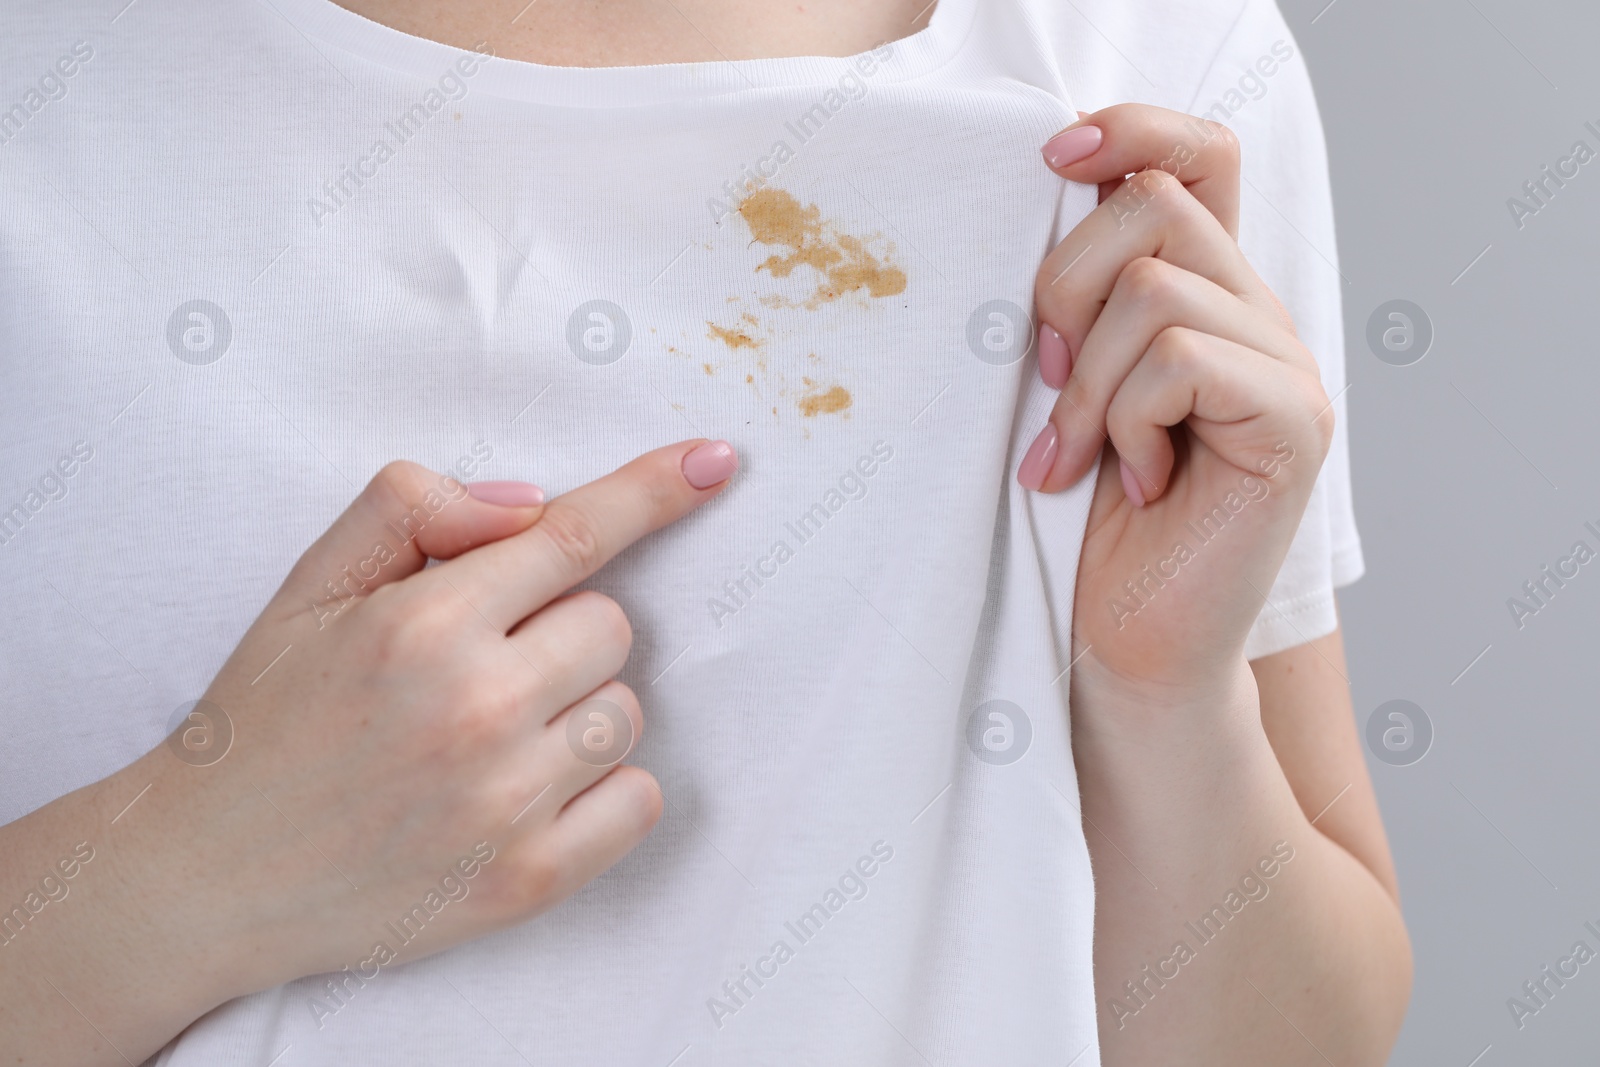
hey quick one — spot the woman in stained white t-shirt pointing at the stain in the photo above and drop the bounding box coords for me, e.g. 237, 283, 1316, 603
0, 0, 1410, 1067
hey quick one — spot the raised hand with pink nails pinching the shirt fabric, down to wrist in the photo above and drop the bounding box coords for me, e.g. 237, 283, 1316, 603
1018, 104, 1333, 693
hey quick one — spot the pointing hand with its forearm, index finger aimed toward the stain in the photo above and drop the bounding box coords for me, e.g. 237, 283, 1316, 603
0, 442, 738, 1064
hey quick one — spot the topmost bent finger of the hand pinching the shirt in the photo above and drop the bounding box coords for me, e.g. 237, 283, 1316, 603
1043, 104, 1240, 238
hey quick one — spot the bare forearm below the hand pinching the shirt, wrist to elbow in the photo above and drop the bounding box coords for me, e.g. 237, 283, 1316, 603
1074, 664, 1411, 1067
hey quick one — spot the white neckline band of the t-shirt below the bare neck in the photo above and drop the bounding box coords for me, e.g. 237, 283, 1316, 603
272, 0, 981, 107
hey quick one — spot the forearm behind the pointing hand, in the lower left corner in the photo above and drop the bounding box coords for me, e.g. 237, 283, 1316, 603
0, 750, 248, 1065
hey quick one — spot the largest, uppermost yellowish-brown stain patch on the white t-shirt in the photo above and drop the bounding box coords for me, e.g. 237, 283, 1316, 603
739, 187, 906, 307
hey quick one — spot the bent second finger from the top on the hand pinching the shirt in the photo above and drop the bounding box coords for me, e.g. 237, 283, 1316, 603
1034, 171, 1283, 387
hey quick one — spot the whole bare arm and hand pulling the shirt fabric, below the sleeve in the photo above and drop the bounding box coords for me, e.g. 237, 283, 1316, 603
1018, 104, 1410, 1067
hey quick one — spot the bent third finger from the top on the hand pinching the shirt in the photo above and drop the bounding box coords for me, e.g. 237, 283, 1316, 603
1042, 258, 1314, 485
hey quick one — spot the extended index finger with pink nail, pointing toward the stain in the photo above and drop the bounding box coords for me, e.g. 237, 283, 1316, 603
438, 442, 738, 630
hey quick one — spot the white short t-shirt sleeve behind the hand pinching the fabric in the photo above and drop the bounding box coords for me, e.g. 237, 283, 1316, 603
1184, 0, 1365, 659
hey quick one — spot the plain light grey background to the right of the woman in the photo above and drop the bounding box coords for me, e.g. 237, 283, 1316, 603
1280, 0, 1600, 1067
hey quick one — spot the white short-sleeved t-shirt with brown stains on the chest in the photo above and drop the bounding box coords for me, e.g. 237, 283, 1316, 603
0, 0, 1360, 1067
